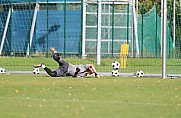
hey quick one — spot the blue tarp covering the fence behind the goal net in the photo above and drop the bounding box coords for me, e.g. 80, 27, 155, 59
0, 10, 81, 53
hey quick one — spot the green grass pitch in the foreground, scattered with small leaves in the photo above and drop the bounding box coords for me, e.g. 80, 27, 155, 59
0, 74, 181, 118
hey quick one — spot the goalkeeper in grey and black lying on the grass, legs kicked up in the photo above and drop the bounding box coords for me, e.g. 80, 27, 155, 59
34, 48, 100, 78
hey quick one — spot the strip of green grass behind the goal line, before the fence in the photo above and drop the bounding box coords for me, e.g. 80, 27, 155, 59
0, 57, 181, 74
